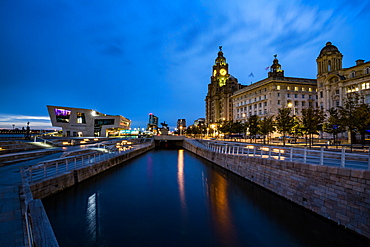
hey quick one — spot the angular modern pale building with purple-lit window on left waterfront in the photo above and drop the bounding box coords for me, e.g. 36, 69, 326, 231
47, 105, 131, 137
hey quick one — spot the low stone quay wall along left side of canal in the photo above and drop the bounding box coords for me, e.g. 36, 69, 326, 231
29, 142, 154, 199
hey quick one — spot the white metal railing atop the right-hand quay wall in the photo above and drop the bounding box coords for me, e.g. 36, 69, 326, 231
190, 140, 370, 170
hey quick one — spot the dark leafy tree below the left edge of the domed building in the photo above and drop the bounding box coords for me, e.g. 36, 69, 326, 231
302, 106, 325, 147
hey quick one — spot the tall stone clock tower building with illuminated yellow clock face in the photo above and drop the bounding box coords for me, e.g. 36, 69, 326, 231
205, 46, 242, 125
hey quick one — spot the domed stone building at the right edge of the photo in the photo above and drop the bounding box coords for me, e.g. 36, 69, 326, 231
316, 42, 370, 111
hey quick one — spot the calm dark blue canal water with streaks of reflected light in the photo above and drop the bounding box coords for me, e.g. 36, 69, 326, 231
43, 150, 370, 247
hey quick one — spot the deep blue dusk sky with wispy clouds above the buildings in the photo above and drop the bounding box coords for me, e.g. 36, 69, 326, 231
0, 0, 370, 129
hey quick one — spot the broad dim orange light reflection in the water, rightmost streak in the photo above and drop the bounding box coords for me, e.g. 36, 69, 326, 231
206, 173, 239, 246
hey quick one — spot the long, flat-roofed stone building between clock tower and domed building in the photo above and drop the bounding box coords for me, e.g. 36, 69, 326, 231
231, 55, 317, 123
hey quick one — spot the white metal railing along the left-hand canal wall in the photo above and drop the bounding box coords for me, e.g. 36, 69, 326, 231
24, 142, 152, 183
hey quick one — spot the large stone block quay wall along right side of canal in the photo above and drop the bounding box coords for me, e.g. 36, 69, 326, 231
184, 140, 370, 238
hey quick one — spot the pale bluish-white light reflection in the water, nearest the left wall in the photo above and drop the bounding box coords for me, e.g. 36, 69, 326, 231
86, 193, 98, 243
